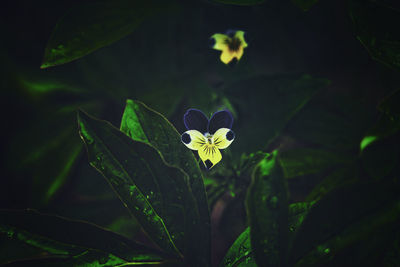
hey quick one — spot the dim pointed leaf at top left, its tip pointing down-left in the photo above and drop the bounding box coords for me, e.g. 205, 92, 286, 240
41, 0, 175, 68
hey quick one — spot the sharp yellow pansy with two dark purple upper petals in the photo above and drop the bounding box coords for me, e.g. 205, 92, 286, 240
181, 109, 235, 170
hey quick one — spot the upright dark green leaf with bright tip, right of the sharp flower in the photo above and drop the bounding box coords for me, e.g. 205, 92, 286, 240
246, 150, 289, 266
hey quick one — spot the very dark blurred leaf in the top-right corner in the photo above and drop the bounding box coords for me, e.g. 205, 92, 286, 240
349, 0, 400, 70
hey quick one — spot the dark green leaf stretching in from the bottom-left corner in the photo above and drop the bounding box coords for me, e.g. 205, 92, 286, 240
0, 210, 161, 261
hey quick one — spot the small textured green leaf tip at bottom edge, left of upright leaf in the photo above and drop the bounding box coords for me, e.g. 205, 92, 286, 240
220, 227, 257, 267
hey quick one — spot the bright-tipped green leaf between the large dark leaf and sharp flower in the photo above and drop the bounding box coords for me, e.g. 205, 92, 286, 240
120, 99, 211, 266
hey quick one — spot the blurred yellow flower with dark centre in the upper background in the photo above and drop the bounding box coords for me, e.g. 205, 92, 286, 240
211, 30, 247, 64
